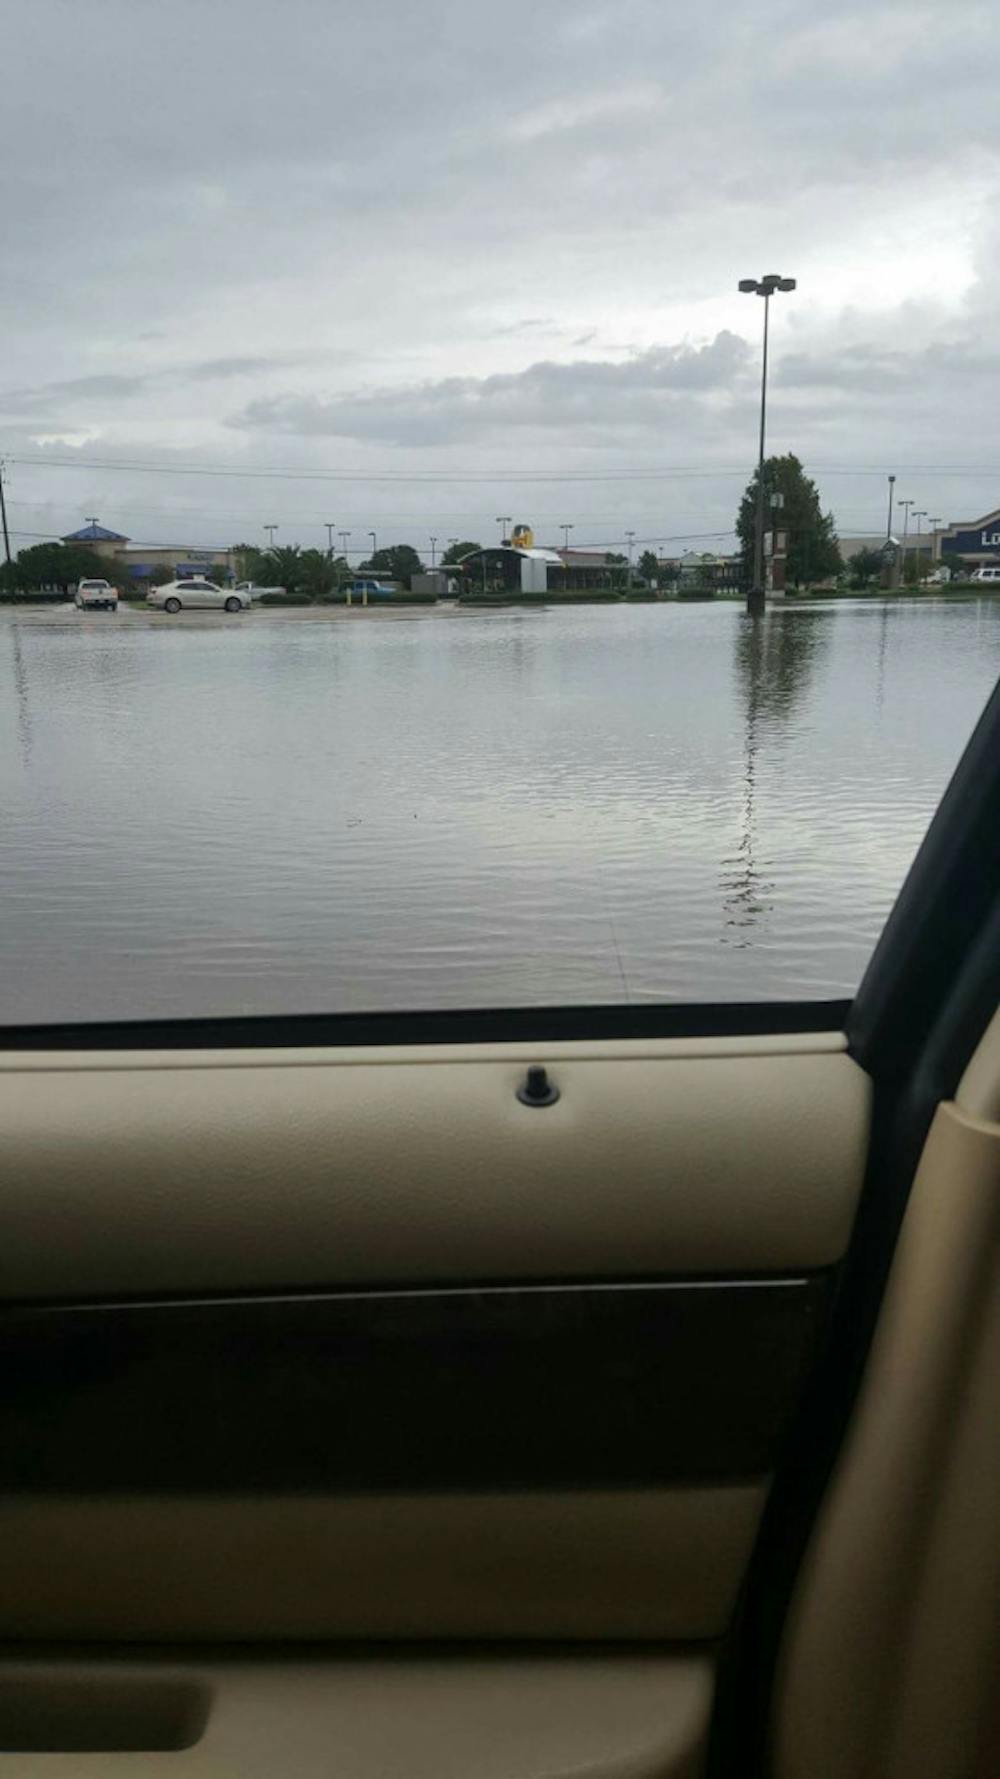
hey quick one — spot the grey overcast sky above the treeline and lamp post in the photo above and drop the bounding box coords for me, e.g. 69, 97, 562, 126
0, 0, 1000, 551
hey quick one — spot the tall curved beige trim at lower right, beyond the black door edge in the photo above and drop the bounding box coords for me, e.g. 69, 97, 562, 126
774, 1081, 1000, 1779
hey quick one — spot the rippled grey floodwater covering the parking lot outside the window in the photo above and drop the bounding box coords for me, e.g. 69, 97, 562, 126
0, 600, 1000, 1023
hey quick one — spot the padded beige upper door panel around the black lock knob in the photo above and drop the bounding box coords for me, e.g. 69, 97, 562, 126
0, 1034, 868, 1299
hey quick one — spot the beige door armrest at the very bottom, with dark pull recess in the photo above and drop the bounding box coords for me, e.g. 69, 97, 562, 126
0, 1651, 712, 1779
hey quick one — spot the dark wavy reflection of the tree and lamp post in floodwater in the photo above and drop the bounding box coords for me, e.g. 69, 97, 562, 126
719, 610, 829, 946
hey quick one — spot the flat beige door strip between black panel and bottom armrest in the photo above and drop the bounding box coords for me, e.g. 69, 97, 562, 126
0, 1484, 765, 1642
